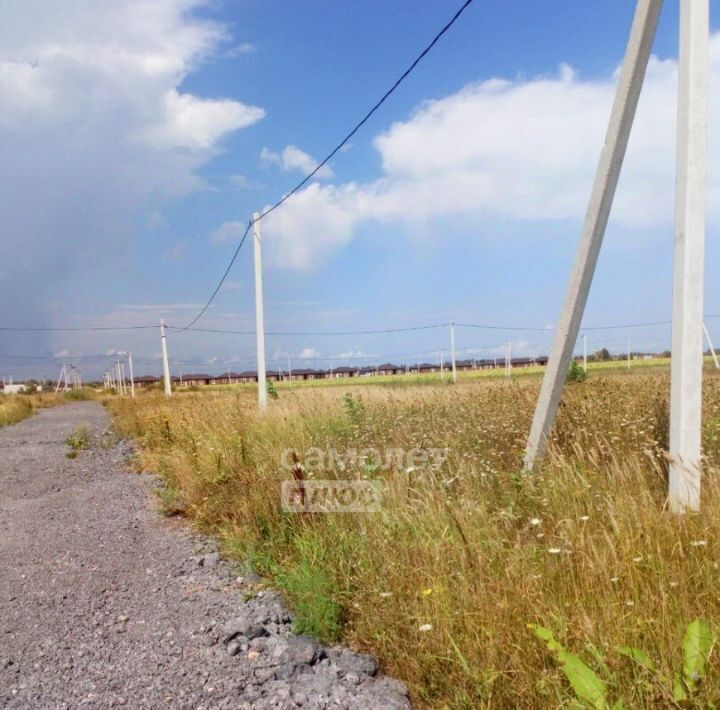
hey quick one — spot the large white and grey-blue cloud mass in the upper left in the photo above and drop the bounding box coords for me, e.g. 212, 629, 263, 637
0, 0, 264, 324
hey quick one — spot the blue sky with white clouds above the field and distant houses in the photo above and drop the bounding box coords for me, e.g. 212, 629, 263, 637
0, 0, 720, 380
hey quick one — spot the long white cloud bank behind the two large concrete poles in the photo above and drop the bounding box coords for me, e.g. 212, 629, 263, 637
265, 41, 720, 269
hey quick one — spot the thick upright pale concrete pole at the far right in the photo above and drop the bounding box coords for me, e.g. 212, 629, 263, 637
668, 0, 710, 513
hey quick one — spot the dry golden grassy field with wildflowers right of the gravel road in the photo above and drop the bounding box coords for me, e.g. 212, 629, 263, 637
110, 367, 720, 708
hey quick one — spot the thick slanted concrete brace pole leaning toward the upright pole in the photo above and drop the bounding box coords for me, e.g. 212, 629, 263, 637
525, 0, 662, 469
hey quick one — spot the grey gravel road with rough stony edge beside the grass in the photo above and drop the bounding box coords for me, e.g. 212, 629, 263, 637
0, 402, 409, 710
